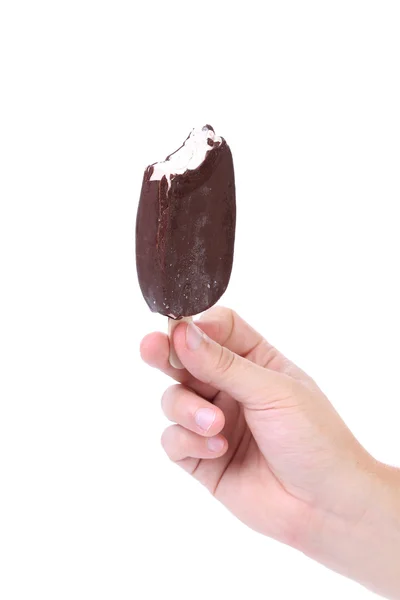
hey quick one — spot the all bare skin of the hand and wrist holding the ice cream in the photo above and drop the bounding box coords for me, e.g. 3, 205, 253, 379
141, 307, 400, 598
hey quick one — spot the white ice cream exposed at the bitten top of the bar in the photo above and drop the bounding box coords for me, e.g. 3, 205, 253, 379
150, 127, 222, 187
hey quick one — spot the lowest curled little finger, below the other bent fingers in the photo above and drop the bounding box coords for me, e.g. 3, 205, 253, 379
161, 425, 228, 462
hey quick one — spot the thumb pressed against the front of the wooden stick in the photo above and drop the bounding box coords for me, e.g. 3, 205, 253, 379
174, 323, 291, 408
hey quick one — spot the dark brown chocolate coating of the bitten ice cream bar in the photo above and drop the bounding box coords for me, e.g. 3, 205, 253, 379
136, 126, 236, 319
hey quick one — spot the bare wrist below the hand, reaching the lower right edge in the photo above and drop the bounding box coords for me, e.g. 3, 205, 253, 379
299, 458, 400, 598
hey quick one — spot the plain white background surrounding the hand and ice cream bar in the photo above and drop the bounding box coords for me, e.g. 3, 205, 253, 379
0, 0, 400, 600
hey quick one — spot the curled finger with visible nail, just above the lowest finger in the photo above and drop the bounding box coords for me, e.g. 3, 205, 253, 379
161, 385, 225, 437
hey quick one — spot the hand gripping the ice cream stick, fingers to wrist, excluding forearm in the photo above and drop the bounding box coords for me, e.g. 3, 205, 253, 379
141, 308, 373, 544
